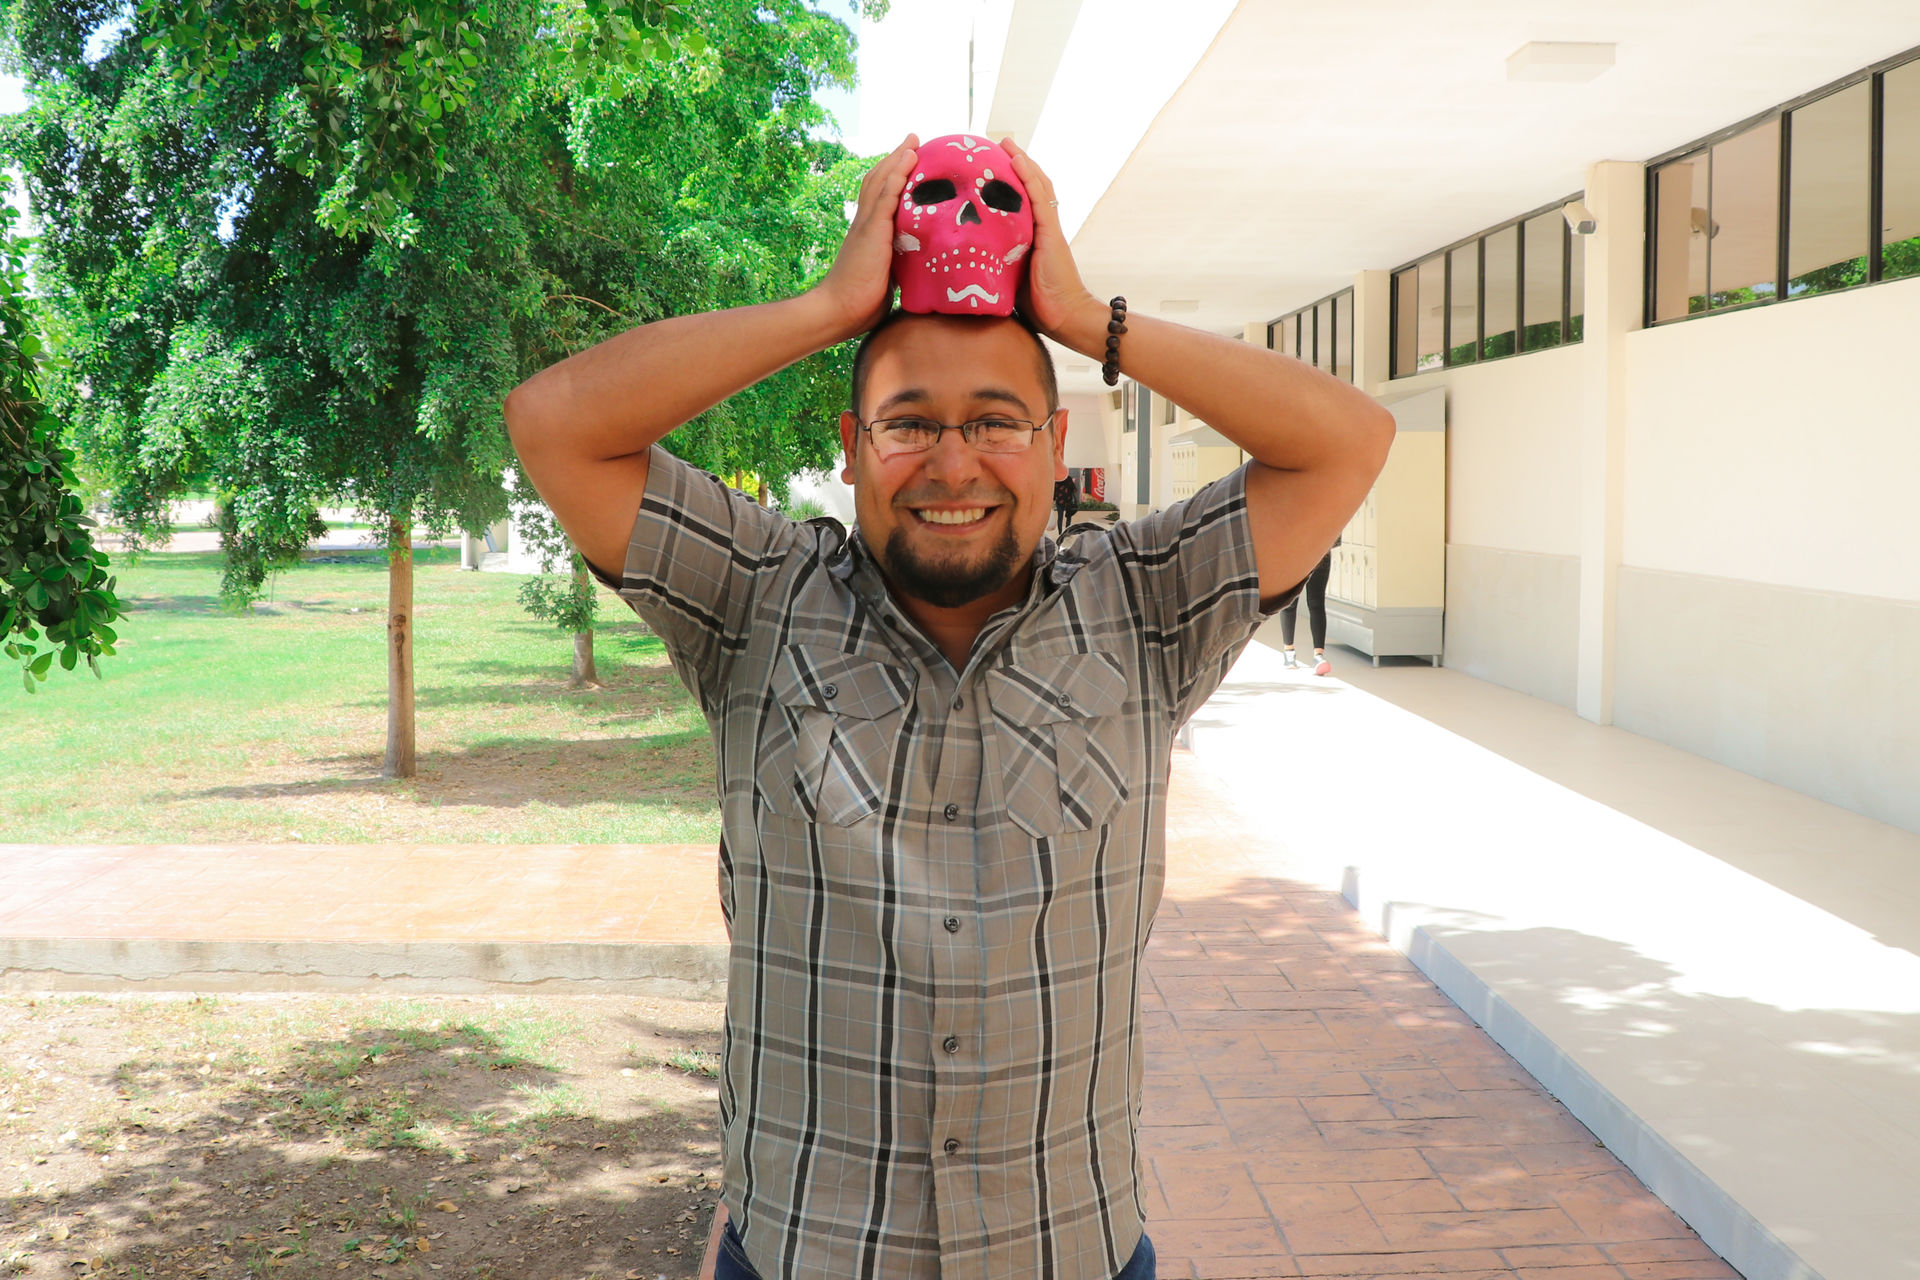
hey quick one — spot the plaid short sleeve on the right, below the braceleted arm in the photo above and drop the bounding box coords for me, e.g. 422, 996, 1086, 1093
1114, 466, 1306, 725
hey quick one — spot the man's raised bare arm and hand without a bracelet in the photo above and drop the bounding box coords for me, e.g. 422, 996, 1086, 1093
505, 136, 920, 576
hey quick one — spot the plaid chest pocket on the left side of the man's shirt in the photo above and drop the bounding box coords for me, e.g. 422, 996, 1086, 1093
755, 645, 914, 827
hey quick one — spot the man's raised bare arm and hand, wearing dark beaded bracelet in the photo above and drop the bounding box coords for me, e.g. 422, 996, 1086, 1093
1002, 142, 1394, 601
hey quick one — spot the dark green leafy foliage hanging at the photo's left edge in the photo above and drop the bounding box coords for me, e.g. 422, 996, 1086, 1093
0, 205, 119, 693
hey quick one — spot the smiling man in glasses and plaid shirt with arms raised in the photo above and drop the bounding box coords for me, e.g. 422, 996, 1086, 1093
507, 136, 1392, 1280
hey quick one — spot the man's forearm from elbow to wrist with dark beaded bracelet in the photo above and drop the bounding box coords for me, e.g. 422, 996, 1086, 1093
1060, 303, 1386, 470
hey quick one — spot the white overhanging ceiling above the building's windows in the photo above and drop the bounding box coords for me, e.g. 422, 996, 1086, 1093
1029, 0, 1920, 382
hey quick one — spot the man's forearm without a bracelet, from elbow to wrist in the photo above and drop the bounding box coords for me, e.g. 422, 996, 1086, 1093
505, 292, 854, 462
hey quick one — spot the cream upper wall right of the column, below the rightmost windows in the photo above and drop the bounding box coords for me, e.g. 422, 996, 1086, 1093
1620, 280, 1920, 601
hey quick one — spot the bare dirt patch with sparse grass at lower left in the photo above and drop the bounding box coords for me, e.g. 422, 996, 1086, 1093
0, 994, 720, 1280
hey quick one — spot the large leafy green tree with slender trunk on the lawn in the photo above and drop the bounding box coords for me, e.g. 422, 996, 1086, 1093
0, 0, 858, 775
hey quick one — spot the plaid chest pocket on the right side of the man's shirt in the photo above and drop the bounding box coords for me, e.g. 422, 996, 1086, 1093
987, 652, 1133, 835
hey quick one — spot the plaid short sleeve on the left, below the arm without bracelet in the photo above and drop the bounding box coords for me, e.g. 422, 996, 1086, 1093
595, 445, 801, 718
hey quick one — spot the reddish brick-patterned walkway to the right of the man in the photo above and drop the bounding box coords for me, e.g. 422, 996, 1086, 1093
1142, 754, 1738, 1280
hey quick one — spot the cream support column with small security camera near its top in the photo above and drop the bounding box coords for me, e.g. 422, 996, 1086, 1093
1574, 159, 1647, 723
